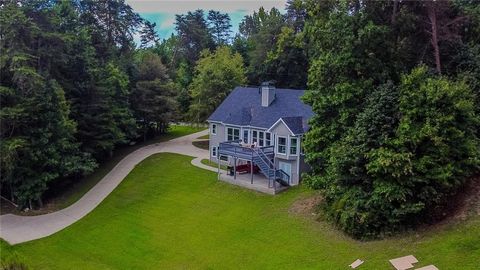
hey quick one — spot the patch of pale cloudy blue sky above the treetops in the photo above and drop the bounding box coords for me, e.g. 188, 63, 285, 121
126, 0, 286, 39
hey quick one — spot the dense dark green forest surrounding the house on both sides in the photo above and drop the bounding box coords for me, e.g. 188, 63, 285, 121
0, 0, 480, 237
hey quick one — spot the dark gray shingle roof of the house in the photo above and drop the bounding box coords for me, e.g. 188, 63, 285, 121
207, 87, 313, 134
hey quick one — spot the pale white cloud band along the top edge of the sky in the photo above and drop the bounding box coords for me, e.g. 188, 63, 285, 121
126, 0, 286, 14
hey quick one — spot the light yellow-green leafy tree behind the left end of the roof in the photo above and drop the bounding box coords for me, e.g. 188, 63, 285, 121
190, 47, 246, 122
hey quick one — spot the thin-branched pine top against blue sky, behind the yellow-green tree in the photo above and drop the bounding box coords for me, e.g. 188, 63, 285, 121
207, 10, 232, 46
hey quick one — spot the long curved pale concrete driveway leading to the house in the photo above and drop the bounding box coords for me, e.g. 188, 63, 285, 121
0, 130, 217, 245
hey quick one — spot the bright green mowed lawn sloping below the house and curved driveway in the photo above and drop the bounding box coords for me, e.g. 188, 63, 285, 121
1, 153, 480, 270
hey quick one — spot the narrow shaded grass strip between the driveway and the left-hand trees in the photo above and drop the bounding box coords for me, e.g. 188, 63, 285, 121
0, 125, 205, 215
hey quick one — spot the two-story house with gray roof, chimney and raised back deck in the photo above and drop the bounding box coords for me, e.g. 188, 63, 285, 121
207, 83, 313, 192
